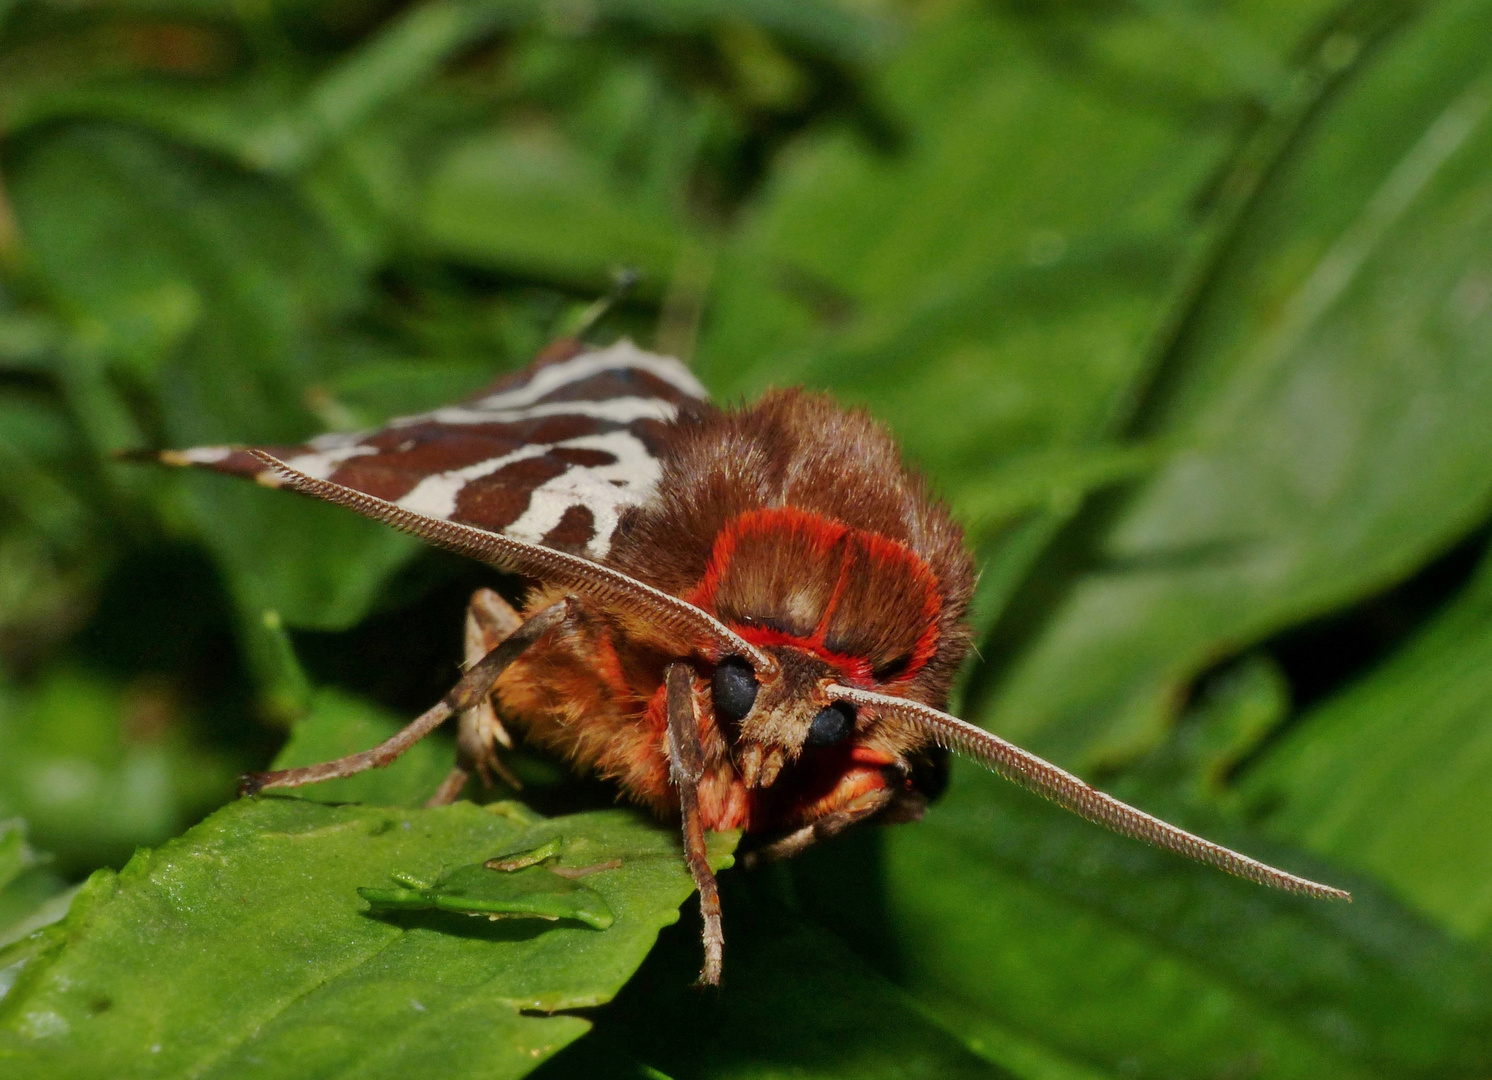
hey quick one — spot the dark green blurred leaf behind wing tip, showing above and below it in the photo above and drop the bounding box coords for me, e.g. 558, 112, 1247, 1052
13, 127, 426, 627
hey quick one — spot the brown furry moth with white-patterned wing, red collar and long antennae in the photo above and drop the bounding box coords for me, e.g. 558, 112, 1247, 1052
161, 339, 1349, 983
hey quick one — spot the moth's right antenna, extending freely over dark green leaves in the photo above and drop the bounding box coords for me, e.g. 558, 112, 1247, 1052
825, 686, 1352, 901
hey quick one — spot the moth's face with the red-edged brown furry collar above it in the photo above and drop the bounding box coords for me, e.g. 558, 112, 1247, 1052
689, 506, 962, 789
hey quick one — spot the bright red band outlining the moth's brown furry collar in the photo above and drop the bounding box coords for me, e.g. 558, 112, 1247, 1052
686, 506, 943, 686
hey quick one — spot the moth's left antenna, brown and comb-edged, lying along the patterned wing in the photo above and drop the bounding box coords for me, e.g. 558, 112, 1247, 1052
249, 450, 776, 674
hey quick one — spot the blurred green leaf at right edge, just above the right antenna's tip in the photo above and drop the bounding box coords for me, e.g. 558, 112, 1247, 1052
1238, 548, 1492, 938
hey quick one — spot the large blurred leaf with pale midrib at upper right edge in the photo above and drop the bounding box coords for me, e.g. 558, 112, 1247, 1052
979, 3, 1492, 764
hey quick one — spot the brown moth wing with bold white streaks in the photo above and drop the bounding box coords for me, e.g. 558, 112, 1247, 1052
161, 342, 707, 561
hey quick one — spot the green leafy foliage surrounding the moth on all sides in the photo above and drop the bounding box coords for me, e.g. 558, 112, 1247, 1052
0, 0, 1492, 1080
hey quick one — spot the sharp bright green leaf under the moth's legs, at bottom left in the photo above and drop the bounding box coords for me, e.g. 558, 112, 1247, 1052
0, 798, 733, 1080
